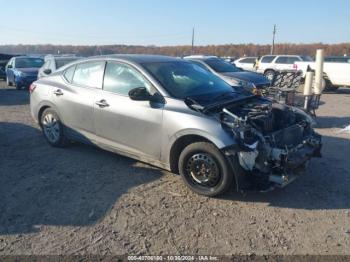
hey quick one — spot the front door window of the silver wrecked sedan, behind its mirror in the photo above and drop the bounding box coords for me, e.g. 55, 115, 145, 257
103, 62, 152, 96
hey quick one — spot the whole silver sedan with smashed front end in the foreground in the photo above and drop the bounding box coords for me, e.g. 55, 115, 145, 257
30, 55, 321, 196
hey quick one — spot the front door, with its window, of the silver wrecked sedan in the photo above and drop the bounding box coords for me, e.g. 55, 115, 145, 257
94, 61, 164, 160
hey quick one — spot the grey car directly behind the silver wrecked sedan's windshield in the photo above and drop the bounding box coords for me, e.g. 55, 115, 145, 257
184, 56, 271, 90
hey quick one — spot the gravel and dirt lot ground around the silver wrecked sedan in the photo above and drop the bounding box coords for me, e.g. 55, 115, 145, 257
0, 83, 350, 255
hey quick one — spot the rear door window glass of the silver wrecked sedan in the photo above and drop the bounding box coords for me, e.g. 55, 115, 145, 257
72, 61, 105, 88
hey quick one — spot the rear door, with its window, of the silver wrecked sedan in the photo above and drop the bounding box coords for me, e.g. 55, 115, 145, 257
52, 61, 105, 142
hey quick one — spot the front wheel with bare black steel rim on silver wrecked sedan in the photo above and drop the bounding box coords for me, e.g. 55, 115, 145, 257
178, 142, 234, 197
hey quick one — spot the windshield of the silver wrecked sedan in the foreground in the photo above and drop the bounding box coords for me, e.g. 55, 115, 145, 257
143, 61, 238, 99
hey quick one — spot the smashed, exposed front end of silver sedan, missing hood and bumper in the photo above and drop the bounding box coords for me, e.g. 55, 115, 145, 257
219, 98, 322, 191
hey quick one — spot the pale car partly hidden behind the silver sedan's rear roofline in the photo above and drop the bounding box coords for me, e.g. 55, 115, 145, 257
38, 54, 81, 79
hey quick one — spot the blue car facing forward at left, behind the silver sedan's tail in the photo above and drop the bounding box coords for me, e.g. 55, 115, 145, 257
6, 56, 44, 89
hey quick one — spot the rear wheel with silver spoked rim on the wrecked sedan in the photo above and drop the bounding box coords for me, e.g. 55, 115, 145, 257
40, 108, 68, 147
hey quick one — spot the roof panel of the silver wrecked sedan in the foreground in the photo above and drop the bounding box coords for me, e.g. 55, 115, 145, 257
86, 54, 181, 64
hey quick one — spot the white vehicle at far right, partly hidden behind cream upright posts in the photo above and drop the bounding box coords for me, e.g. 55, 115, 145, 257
295, 61, 350, 91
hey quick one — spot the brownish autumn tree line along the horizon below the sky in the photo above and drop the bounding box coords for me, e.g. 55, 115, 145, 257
0, 43, 350, 57
